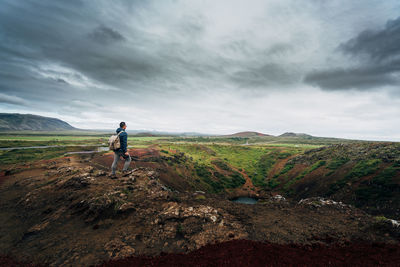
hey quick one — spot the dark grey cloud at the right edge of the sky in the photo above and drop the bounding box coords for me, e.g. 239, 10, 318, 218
304, 17, 400, 90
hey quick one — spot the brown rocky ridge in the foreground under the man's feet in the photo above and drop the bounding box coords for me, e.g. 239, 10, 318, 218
0, 154, 400, 266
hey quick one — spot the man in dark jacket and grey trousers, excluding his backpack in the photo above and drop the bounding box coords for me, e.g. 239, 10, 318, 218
110, 122, 131, 178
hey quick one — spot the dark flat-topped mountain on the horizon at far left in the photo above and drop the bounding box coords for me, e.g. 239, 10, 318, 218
0, 113, 79, 131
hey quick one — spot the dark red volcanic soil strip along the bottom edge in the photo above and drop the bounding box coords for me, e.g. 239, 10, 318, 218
101, 240, 400, 267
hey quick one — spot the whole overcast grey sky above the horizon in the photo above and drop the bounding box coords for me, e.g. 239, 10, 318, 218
0, 0, 400, 141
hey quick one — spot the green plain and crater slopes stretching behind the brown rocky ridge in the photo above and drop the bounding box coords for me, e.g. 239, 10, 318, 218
0, 133, 400, 220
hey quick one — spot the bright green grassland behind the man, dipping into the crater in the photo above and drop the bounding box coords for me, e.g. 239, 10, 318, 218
0, 133, 312, 186
